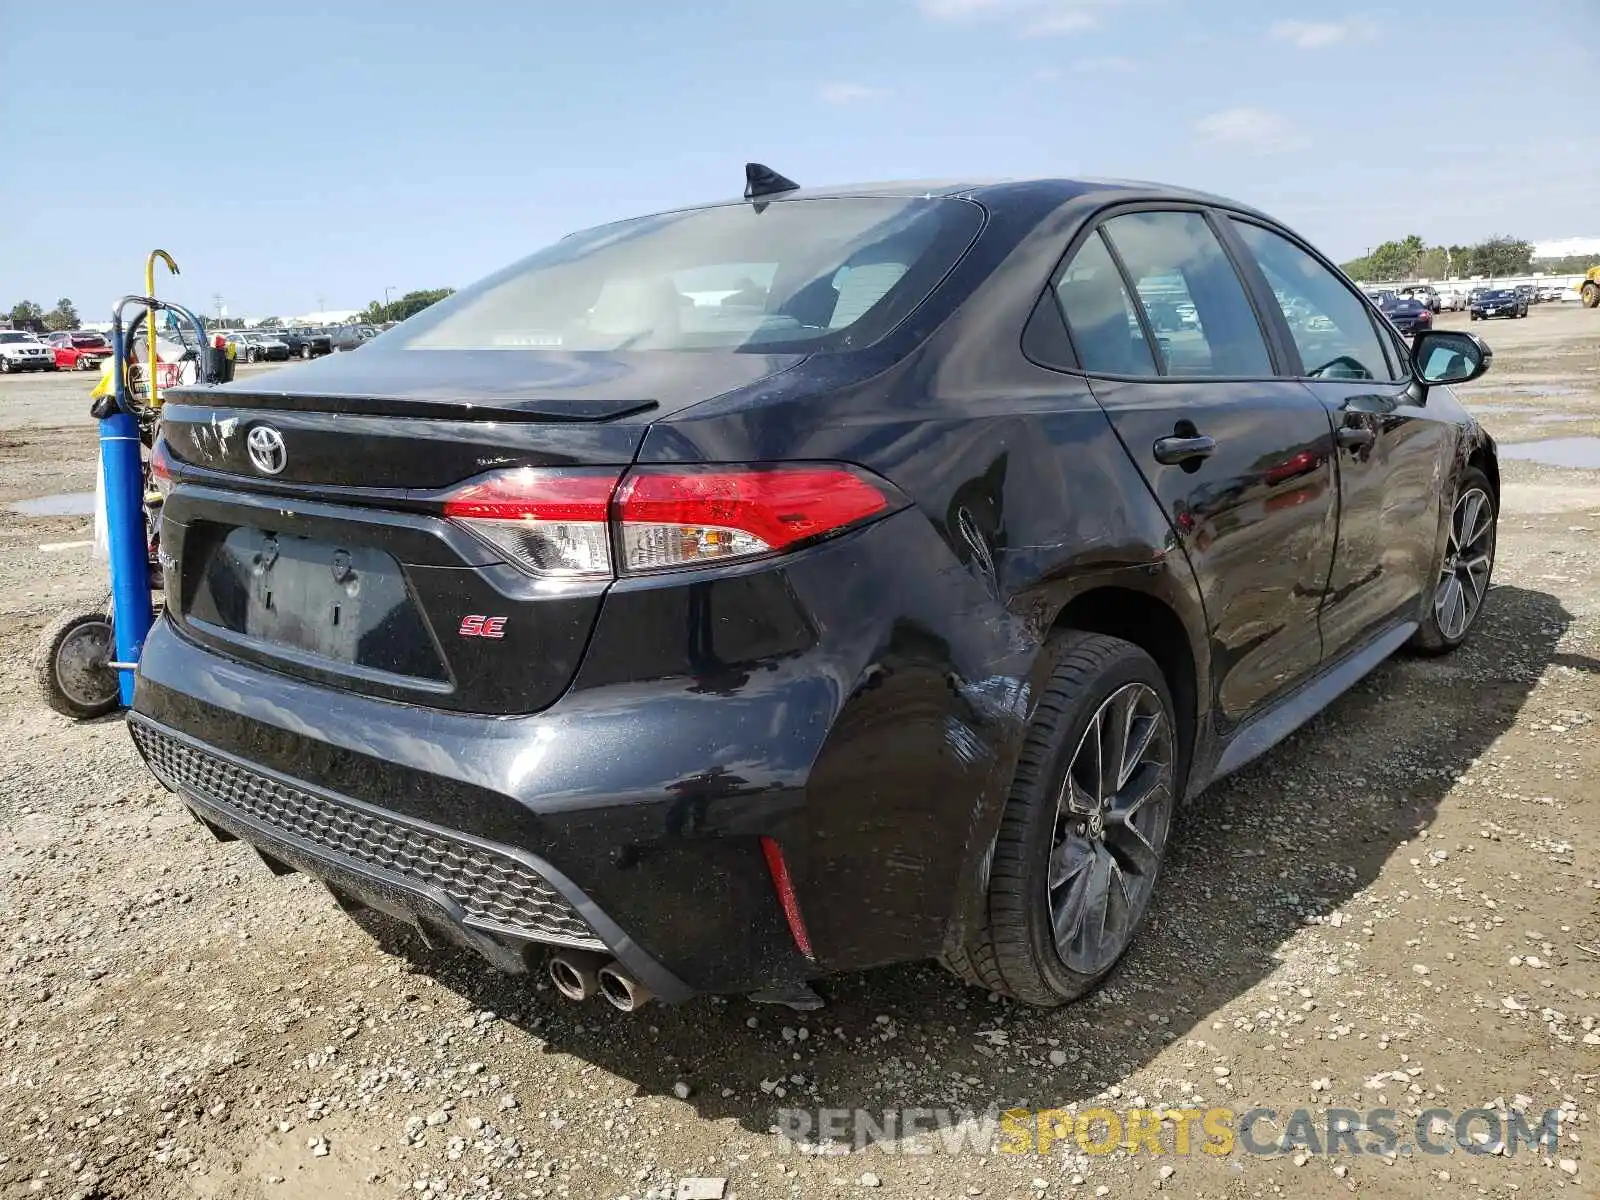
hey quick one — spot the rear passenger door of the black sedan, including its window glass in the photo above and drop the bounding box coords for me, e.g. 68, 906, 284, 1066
1054, 208, 1336, 725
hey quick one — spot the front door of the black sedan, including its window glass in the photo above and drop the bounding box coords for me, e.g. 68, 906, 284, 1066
1232, 219, 1456, 656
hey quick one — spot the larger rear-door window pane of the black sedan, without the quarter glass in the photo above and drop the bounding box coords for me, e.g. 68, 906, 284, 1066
1102, 213, 1272, 378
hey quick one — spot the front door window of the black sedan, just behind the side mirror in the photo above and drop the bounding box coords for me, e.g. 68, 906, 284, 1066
1234, 221, 1394, 379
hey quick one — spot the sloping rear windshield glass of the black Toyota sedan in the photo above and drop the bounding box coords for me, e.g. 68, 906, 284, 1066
393, 197, 982, 352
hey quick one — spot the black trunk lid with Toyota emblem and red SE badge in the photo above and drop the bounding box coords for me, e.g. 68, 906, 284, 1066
162, 349, 800, 714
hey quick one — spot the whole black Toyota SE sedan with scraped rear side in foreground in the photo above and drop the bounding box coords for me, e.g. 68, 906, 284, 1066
130, 166, 1499, 1008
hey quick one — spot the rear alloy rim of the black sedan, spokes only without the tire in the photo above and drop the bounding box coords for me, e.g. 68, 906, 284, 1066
1046, 683, 1173, 974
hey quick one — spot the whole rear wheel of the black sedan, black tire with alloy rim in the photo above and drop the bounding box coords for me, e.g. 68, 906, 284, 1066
946, 632, 1178, 1008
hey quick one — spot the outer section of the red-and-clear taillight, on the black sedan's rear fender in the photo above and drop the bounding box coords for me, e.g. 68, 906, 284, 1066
616, 464, 890, 573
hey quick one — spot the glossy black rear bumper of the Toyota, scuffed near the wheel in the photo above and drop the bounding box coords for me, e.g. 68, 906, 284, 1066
130, 512, 1035, 998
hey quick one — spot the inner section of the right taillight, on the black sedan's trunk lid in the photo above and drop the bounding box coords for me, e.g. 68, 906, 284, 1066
445, 467, 621, 579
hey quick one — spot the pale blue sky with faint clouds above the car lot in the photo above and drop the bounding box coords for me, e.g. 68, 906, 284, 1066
0, 0, 1600, 320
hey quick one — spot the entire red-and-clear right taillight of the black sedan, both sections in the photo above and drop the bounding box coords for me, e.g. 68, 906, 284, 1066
445, 464, 890, 579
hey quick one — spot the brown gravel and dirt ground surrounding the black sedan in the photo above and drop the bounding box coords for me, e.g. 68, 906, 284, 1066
0, 312, 1600, 1200
